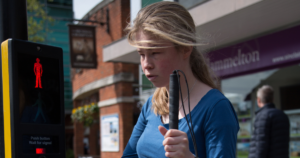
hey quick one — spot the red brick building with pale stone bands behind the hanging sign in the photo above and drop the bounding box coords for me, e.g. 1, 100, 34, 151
72, 0, 139, 158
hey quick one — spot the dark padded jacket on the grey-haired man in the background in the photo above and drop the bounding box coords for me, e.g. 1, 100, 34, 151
249, 103, 290, 158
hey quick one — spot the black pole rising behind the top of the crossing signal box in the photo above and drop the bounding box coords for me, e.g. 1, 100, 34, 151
0, 0, 28, 43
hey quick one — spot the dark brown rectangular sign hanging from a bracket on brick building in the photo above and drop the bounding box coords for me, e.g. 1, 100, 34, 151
68, 25, 97, 68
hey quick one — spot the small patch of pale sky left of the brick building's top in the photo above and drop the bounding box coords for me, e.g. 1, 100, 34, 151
73, 0, 102, 19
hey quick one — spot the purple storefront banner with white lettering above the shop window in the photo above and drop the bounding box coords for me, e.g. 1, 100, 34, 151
208, 26, 300, 78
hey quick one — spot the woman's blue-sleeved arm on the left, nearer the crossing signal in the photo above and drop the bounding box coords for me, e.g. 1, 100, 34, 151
122, 99, 151, 158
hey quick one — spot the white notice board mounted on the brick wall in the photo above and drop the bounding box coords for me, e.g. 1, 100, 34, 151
101, 114, 119, 152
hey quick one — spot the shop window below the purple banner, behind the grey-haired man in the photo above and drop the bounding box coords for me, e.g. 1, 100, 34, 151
221, 65, 300, 158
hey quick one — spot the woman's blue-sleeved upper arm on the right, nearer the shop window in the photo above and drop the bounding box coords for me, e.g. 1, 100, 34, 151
204, 99, 239, 158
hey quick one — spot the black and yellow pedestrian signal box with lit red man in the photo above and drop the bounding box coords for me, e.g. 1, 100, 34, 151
0, 39, 65, 158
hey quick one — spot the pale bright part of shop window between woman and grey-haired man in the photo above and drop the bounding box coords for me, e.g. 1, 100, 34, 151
221, 69, 277, 158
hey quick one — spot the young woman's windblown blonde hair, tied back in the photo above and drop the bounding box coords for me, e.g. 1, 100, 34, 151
126, 1, 217, 115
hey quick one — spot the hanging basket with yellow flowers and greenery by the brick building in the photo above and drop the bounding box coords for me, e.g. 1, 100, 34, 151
71, 103, 99, 127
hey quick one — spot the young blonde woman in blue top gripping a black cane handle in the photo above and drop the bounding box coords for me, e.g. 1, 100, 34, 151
123, 1, 239, 158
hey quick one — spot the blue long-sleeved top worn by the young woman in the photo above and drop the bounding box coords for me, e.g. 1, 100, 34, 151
122, 89, 239, 158
